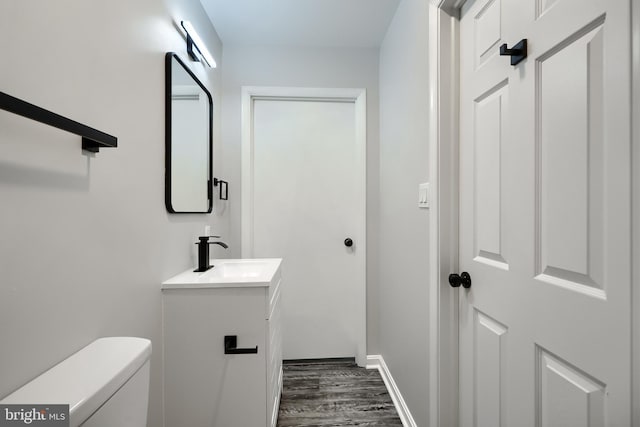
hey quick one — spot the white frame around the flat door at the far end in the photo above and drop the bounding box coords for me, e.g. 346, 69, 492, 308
240, 86, 367, 366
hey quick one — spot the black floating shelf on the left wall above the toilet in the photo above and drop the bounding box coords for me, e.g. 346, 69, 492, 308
0, 92, 118, 153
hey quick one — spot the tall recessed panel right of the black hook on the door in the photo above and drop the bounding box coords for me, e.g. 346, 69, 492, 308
536, 22, 606, 297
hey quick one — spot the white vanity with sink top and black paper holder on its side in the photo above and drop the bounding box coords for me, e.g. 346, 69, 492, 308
162, 259, 282, 427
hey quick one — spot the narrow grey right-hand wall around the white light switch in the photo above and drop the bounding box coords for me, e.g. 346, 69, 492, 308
379, 0, 429, 426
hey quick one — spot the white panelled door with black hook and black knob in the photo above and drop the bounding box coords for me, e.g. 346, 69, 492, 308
459, 0, 631, 427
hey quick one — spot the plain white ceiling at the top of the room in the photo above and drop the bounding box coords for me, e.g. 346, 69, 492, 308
200, 0, 400, 48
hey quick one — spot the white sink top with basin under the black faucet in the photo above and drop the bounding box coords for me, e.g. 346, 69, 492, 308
162, 258, 282, 289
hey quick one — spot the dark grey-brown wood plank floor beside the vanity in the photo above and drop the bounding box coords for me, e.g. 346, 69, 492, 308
278, 359, 402, 427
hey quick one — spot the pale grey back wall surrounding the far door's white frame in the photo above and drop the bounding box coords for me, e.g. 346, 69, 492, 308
222, 45, 379, 354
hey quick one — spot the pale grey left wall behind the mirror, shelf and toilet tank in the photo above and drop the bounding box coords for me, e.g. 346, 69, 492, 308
0, 0, 228, 427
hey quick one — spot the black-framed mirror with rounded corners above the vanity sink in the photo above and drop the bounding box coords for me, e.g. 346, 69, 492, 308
165, 52, 213, 213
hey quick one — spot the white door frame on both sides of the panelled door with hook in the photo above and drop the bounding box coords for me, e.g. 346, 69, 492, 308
428, 0, 640, 427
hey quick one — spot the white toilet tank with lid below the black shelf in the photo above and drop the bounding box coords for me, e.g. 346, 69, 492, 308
0, 337, 151, 427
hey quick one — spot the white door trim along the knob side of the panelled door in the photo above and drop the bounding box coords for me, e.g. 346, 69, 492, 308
428, 0, 465, 427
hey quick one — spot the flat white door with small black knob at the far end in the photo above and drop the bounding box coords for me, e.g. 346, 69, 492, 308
253, 99, 364, 359
